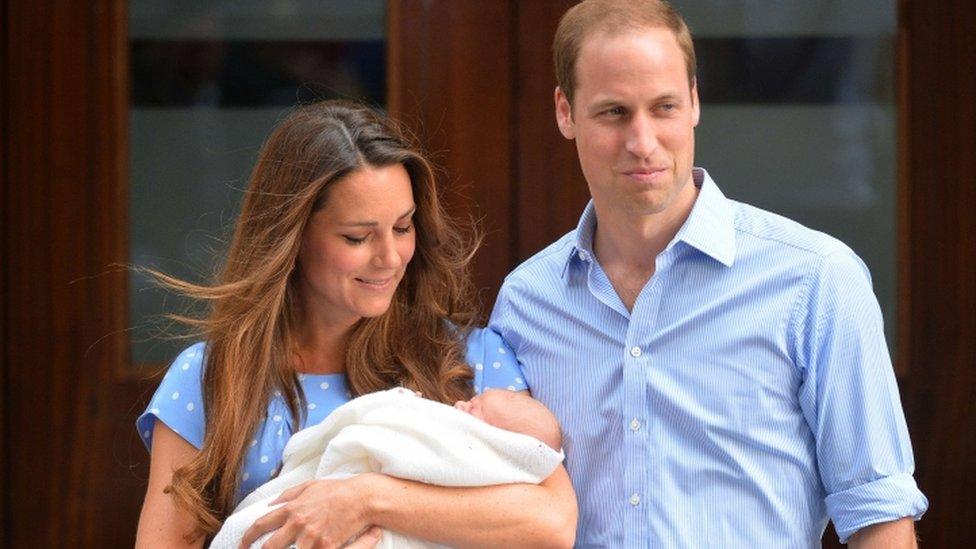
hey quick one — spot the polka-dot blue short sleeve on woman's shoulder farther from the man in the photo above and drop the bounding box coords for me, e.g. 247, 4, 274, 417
136, 343, 205, 451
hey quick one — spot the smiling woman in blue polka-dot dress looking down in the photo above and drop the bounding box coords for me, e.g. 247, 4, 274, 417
136, 101, 576, 548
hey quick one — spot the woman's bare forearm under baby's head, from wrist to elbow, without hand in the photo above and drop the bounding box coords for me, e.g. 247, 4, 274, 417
366, 467, 577, 547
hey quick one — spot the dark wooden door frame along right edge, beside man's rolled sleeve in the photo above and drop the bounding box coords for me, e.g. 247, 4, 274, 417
898, 0, 976, 547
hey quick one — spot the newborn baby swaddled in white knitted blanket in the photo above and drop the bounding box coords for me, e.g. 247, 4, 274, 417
211, 388, 563, 548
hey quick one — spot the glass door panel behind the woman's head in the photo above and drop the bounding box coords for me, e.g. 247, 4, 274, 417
129, 0, 386, 364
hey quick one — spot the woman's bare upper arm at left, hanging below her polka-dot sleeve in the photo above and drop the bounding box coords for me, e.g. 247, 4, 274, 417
136, 421, 204, 548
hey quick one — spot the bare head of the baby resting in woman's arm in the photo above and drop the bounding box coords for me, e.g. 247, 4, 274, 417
454, 389, 563, 452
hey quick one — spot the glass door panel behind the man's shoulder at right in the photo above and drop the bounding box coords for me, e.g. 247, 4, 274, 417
672, 0, 897, 354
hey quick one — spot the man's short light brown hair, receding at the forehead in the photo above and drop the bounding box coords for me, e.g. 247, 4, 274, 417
552, 0, 696, 107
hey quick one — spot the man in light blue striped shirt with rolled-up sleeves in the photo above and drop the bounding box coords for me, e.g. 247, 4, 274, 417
491, 0, 928, 547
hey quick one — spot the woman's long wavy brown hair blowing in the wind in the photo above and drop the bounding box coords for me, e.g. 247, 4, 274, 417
150, 101, 474, 539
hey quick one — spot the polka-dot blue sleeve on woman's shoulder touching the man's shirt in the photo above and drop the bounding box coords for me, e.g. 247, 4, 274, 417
466, 328, 529, 393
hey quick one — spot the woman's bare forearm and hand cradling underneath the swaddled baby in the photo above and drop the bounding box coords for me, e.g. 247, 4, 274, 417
242, 466, 577, 547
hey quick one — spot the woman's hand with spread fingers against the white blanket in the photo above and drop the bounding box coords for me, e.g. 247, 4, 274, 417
241, 475, 380, 549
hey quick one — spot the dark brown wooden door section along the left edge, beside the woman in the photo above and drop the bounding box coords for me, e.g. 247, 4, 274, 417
0, 0, 148, 547
